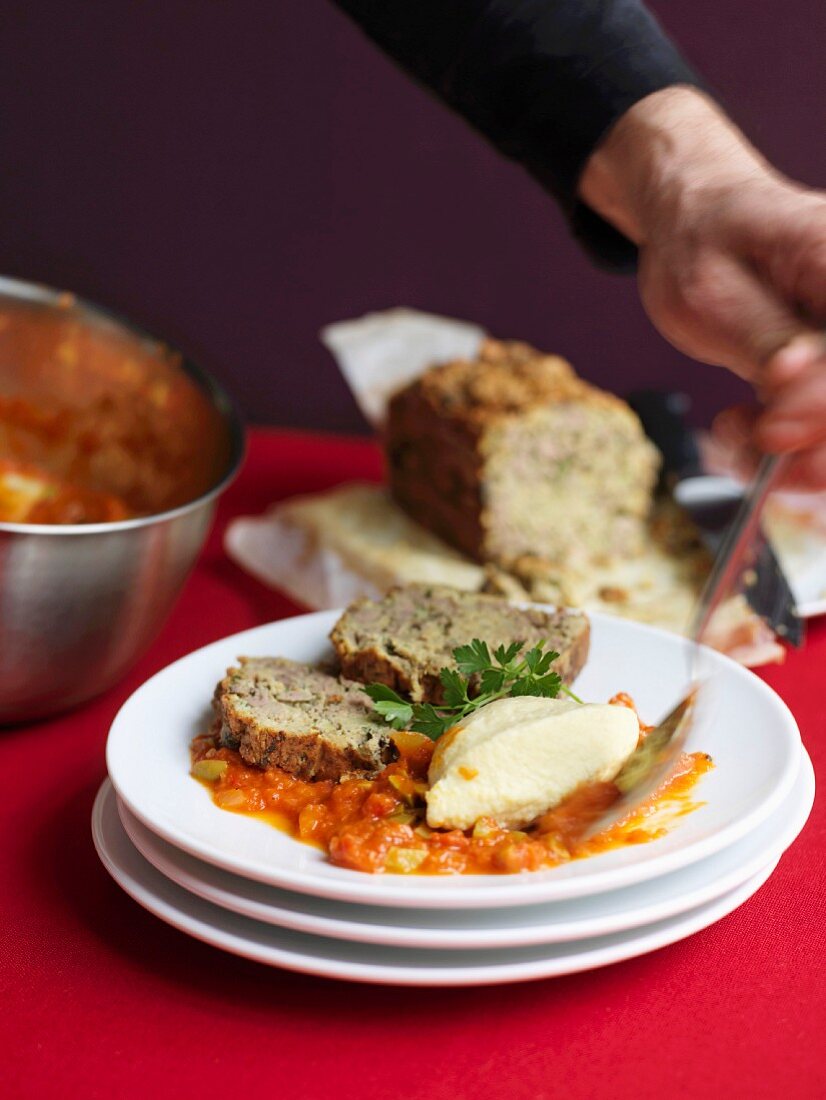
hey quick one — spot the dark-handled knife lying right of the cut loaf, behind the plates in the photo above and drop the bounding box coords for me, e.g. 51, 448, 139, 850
629, 389, 804, 647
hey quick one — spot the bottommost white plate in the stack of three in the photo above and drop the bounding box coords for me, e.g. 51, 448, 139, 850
92, 784, 777, 986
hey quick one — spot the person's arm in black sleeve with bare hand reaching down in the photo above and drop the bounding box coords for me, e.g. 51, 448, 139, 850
339, 0, 826, 488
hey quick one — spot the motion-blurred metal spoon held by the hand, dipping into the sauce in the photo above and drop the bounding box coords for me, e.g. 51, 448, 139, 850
583, 454, 785, 839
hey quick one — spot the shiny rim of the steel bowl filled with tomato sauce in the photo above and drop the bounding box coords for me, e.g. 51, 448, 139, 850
0, 275, 246, 538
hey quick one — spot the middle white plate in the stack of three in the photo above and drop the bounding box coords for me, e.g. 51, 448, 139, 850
119, 750, 815, 949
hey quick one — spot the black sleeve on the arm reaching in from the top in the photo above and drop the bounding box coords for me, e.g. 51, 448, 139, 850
334, 0, 700, 270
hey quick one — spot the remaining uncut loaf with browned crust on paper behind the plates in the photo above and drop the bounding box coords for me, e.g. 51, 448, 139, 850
385, 340, 659, 568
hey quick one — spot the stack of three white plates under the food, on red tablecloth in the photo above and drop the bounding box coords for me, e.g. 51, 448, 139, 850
92, 613, 814, 986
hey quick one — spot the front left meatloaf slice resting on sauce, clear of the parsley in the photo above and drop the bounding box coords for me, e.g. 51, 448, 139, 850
213, 657, 398, 779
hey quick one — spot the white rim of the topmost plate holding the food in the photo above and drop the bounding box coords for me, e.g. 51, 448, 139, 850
106, 605, 802, 909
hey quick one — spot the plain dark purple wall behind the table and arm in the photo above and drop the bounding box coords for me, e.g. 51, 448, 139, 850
0, 0, 826, 430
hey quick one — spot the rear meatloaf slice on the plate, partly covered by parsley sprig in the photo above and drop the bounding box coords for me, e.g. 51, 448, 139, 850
330, 584, 590, 703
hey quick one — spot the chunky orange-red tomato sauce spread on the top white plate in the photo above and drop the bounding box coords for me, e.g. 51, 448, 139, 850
191, 695, 713, 875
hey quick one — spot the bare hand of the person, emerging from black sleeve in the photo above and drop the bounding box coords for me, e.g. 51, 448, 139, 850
580, 88, 826, 488
